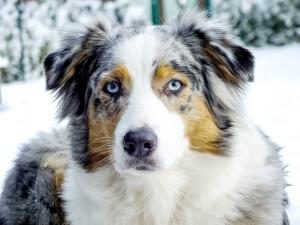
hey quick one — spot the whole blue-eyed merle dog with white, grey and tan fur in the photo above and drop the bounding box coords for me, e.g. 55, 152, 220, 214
0, 12, 288, 225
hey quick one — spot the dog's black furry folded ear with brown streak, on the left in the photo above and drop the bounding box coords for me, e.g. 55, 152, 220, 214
44, 23, 107, 118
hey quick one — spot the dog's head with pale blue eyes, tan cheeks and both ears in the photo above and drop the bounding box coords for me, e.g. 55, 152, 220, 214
44, 13, 254, 173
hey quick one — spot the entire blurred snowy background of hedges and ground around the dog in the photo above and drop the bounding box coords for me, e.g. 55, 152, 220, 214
0, 0, 300, 225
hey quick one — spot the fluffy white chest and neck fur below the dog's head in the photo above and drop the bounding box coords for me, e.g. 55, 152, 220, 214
63, 123, 282, 225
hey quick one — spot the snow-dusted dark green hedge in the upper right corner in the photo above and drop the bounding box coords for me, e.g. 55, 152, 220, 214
215, 0, 300, 46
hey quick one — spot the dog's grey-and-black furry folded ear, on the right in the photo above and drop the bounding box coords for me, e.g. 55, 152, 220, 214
174, 12, 254, 86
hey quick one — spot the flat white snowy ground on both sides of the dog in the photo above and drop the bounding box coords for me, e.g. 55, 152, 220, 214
0, 45, 300, 225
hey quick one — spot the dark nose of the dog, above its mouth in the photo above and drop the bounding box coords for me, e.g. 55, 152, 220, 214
123, 127, 157, 159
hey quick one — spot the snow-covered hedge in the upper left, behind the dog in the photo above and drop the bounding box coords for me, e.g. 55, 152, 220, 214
0, 0, 149, 82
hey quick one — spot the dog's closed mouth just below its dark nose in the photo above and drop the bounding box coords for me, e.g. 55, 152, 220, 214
126, 158, 158, 172
